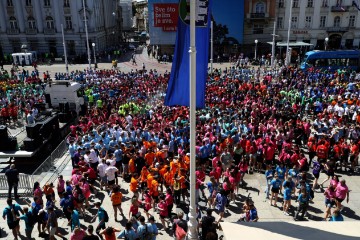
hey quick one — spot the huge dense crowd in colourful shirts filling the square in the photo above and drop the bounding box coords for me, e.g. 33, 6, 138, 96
0, 57, 360, 239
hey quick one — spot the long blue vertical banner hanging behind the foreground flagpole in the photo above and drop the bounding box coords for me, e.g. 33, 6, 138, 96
165, 0, 211, 109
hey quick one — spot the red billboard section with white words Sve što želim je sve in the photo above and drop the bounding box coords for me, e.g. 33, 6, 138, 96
154, 3, 179, 32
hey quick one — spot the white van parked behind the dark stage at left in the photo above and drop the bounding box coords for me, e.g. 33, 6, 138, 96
45, 80, 84, 114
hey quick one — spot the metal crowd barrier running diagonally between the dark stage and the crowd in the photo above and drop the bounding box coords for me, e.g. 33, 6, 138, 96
31, 137, 68, 183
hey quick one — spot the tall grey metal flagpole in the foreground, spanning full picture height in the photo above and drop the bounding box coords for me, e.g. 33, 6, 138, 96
188, 0, 198, 239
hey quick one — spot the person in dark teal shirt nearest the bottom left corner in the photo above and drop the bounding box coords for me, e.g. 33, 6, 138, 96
3, 198, 24, 239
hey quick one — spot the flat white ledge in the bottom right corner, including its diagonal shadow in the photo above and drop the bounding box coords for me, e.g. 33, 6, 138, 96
220, 221, 360, 240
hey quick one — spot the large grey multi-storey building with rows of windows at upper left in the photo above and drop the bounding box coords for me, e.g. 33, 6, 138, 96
0, 0, 121, 57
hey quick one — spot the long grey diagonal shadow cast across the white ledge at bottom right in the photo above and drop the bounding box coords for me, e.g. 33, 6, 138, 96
236, 222, 359, 240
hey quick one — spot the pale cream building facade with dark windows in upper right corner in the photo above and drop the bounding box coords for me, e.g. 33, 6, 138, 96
276, 0, 360, 50
